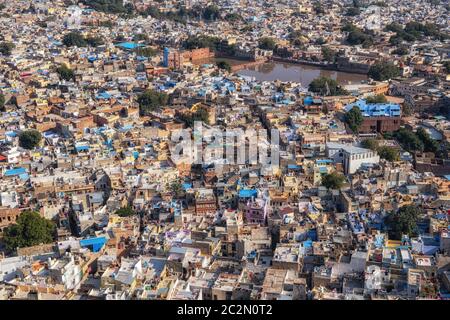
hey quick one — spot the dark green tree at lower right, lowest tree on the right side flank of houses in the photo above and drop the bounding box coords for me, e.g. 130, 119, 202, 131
385, 205, 422, 240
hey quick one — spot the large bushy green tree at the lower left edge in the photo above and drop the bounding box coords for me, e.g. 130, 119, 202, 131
3, 211, 56, 251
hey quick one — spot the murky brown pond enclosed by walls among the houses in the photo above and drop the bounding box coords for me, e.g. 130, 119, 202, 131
237, 62, 367, 87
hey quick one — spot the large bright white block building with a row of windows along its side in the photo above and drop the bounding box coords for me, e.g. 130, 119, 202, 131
325, 142, 380, 174
